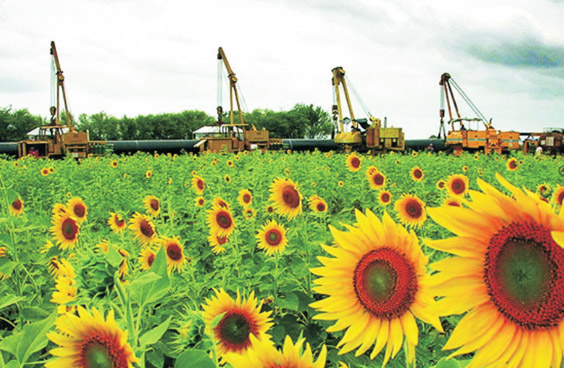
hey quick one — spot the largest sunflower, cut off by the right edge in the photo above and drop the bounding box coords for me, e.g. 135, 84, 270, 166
427, 174, 564, 367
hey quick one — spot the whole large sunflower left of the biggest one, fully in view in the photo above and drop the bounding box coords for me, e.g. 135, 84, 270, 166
310, 210, 442, 366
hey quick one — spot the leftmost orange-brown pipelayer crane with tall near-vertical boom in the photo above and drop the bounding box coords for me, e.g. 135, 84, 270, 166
18, 41, 106, 158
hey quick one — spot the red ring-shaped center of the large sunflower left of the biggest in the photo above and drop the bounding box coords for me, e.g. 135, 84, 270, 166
353, 248, 418, 319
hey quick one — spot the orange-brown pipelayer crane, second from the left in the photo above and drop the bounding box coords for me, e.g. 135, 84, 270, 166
195, 47, 282, 152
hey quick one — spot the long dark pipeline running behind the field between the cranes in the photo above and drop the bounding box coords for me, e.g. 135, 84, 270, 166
0, 139, 445, 156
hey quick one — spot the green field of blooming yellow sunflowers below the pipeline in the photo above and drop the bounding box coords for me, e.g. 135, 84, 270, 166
0, 151, 564, 368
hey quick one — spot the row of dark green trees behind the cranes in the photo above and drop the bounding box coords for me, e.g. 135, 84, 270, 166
0, 104, 333, 142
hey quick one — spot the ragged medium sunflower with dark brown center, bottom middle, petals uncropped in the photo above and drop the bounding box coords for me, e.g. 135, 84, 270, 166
202, 289, 272, 356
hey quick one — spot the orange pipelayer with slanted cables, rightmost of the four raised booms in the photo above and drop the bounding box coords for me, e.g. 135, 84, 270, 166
439, 73, 520, 156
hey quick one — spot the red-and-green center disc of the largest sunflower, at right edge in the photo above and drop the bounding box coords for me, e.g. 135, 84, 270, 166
484, 223, 564, 330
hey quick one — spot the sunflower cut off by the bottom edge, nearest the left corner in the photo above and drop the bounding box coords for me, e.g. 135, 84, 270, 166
45, 307, 139, 368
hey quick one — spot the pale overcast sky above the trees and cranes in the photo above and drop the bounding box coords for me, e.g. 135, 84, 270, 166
0, 0, 564, 139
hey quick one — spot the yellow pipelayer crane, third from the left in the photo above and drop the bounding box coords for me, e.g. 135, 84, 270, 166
331, 66, 405, 153
